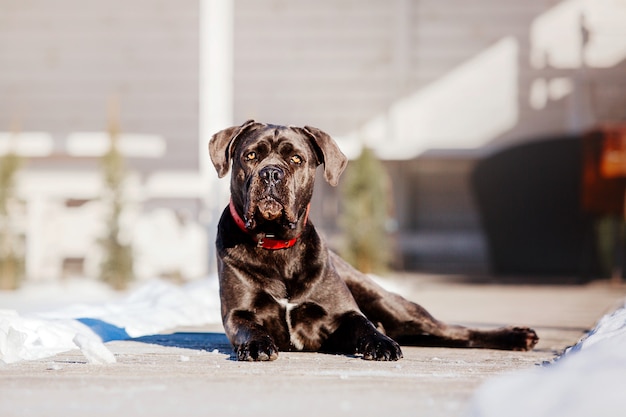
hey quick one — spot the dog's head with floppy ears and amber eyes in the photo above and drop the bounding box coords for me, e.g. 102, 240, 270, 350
209, 120, 347, 234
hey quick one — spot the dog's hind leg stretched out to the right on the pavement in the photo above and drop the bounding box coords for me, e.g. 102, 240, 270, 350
332, 255, 539, 350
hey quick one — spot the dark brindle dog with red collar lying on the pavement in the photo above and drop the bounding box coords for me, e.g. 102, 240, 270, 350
209, 120, 539, 361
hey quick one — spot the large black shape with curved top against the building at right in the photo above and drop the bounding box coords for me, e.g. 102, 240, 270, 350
471, 137, 598, 277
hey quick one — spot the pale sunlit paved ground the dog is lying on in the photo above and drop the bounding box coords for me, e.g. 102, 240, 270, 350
0, 276, 626, 417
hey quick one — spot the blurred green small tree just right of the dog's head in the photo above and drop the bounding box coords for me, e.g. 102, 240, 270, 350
339, 148, 390, 273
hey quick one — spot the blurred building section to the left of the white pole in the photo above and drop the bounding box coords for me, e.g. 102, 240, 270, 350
0, 0, 208, 279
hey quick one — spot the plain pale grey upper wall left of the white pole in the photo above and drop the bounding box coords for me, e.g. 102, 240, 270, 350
0, 0, 199, 169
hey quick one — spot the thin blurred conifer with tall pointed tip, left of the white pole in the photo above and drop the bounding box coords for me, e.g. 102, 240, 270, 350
100, 100, 133, 290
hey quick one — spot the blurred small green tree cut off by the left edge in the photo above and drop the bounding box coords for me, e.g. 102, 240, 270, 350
0, 152, 24, 290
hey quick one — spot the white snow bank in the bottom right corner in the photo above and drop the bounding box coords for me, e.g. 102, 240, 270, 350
466, 306, 626, 417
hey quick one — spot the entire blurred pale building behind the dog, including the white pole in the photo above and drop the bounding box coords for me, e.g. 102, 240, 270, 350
0, 0, 626, 278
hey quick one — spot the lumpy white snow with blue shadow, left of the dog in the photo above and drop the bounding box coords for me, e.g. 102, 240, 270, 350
0, 276, 220, 364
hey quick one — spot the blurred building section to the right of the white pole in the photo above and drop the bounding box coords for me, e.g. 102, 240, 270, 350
234, 0, 626, 274
